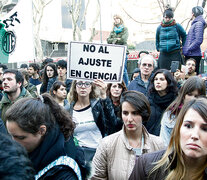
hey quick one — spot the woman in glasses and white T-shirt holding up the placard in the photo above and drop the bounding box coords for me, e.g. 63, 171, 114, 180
68, 80, 113, 162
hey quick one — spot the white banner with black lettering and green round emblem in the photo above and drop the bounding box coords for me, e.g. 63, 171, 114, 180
0, 0, 35, 63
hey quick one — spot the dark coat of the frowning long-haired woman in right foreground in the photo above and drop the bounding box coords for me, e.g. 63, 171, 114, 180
129, 150, 207, 180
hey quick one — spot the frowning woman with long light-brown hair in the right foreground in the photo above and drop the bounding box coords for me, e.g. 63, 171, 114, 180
129, 98, 207, 180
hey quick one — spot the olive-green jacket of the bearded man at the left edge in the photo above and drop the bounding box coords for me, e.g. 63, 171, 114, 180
0, 87, 32, 122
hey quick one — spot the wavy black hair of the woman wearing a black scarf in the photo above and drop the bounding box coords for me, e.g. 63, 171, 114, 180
149, 69, 178, 94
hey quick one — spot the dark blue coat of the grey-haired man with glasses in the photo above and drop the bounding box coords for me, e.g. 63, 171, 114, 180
127, 75, 152, 96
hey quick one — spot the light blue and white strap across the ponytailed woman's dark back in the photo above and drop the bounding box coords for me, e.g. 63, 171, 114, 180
35, 156, 82, 180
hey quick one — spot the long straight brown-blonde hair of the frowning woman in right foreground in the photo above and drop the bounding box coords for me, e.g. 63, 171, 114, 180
149, 97, 207, 180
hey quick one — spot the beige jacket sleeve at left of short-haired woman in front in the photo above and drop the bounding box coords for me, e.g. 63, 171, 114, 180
91, 140, 108, 180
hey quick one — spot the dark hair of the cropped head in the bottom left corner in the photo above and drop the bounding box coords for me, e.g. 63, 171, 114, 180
0, 133, 35, 180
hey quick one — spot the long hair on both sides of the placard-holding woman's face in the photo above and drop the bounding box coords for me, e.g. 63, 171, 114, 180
67, 80, 99, 103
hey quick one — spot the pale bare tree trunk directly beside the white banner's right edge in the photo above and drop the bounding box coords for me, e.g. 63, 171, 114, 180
32, 0, 53, 59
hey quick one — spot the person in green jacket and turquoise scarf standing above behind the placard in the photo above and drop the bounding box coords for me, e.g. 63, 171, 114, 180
107, 15, 129, 86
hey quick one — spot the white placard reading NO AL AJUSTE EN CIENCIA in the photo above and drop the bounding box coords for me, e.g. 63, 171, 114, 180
67, 41, 126, 82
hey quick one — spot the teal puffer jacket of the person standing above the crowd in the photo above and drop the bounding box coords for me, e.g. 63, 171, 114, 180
156, 23, 186, 53
